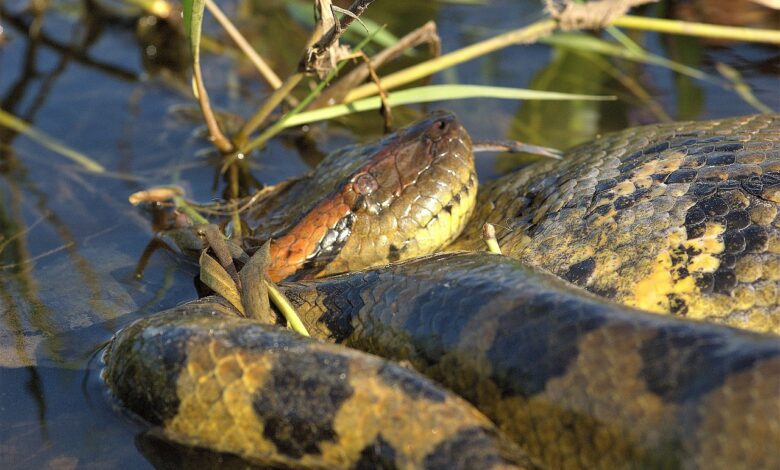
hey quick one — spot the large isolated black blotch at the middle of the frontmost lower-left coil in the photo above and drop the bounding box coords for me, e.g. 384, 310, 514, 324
252, 351, 353, 458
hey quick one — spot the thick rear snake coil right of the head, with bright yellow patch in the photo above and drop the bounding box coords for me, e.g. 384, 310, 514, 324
453, 114, 780, 333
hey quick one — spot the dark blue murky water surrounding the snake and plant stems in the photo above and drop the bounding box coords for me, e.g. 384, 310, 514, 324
0, 0, 780, 468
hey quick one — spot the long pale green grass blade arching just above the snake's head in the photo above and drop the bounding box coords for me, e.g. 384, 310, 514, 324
283, 85, 615, 127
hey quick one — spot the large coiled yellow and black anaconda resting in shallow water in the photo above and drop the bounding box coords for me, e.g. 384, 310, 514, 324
104, 113, 780, 468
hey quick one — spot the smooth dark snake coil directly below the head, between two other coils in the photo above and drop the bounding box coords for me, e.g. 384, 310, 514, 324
285, 253, 780, 469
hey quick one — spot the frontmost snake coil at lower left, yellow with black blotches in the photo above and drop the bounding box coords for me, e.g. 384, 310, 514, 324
105, 298, 533, 470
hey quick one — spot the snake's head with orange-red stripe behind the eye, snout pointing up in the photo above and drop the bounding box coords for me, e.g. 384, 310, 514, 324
269, 113, 477, 280
